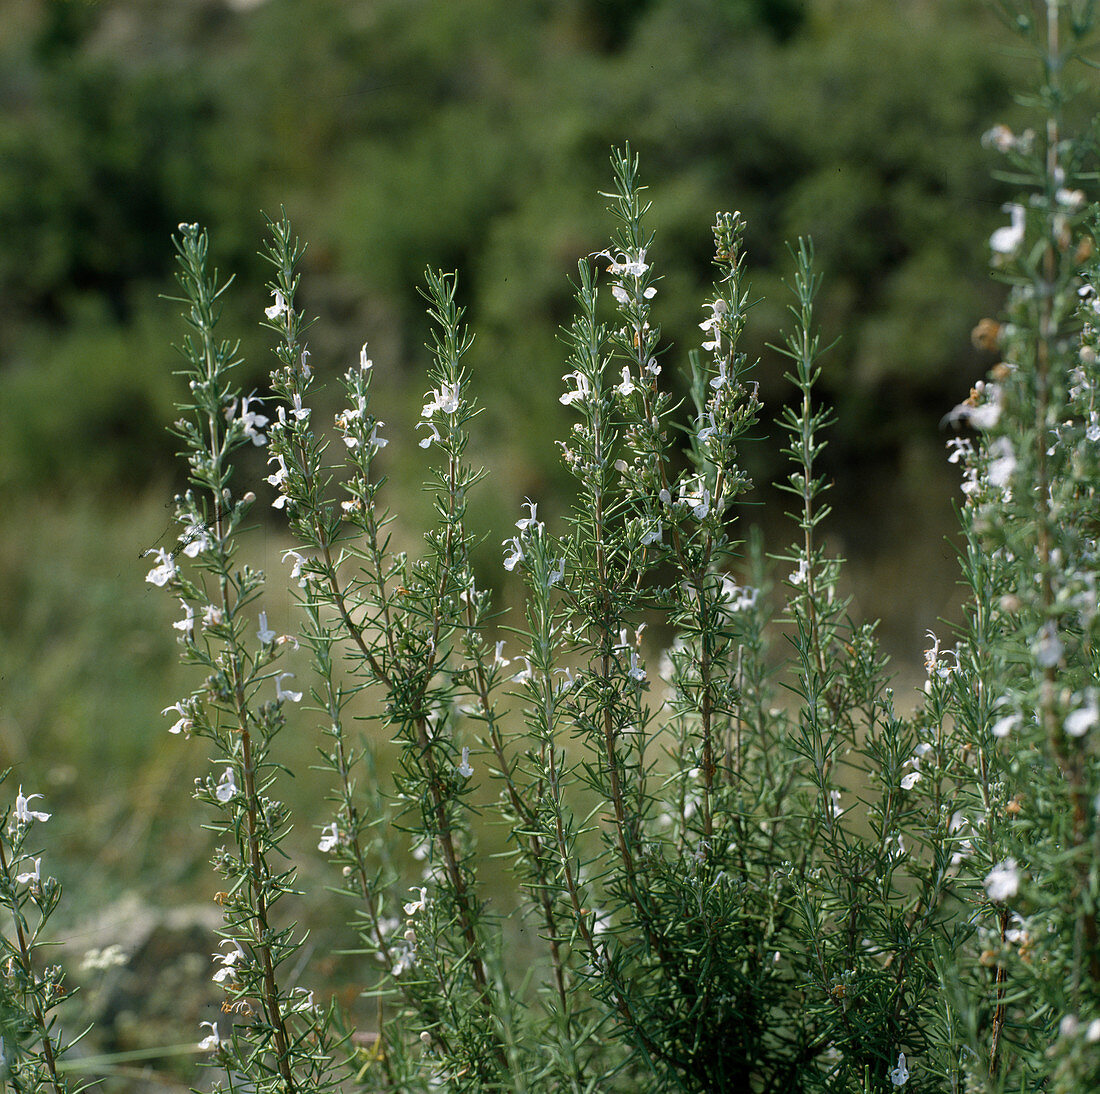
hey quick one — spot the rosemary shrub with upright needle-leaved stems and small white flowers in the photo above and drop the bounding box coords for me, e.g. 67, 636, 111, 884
0, 0, 1100, 1094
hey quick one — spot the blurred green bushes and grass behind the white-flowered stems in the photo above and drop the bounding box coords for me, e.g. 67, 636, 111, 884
0, 0, 1047, 1077
